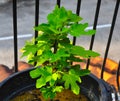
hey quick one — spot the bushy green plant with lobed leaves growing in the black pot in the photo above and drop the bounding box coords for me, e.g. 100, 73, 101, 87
22, 6, 99, 99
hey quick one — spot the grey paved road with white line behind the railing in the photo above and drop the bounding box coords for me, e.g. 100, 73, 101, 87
0, 0, 120, 67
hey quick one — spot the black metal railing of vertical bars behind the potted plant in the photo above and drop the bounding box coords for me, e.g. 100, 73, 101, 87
13, 0, 120, 91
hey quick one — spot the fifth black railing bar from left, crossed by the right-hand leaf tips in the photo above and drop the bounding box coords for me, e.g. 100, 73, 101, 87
86, 0, 101, 69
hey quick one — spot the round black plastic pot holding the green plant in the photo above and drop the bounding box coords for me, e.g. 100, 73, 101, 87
0, 69, 115, 101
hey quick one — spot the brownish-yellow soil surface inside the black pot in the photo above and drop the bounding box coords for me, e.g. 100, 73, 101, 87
10, 89, 89, 101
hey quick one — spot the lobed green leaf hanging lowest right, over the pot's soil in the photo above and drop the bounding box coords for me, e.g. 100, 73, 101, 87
62, 70, 81, 94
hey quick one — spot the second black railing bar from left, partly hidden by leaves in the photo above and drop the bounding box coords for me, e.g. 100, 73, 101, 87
34, 0, 39, 66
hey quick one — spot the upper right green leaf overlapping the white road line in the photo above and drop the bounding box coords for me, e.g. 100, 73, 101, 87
70, 23, 96, 37
